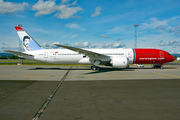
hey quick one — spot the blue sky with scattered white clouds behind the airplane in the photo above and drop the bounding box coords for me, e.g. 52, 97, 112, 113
0, 0, 180, 54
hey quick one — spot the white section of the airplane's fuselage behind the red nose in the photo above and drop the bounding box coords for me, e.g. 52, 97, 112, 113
25, 49, 134, 64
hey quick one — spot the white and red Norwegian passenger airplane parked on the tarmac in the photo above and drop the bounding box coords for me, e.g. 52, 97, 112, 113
4, 26, 175, 71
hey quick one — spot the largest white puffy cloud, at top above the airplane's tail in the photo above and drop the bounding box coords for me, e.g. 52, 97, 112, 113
32, 0, 83, 19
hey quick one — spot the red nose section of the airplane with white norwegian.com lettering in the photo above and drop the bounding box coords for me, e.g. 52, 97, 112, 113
134, 49, 174, 64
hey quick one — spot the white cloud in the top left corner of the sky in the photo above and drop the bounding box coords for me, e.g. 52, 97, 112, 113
0, 0, 28, 14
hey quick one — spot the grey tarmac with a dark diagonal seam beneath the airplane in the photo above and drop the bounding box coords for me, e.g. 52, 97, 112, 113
0, 64, 180, 120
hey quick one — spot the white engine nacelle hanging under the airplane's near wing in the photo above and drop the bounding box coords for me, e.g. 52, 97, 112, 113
110, 57, 129, 68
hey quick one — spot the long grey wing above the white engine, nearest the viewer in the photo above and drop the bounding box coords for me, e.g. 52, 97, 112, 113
54, 44, 109, 57
